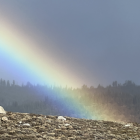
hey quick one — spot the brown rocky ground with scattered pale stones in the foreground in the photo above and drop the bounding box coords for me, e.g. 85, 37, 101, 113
0, 112, 140, 140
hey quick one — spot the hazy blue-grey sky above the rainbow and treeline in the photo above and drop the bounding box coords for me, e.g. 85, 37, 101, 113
0, 0, 140, 86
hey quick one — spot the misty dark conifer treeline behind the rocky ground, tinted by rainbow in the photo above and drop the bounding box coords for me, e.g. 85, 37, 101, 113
0, 79, 140, 123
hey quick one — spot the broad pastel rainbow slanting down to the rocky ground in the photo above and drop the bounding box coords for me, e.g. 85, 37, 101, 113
0, 18, 120, 121
